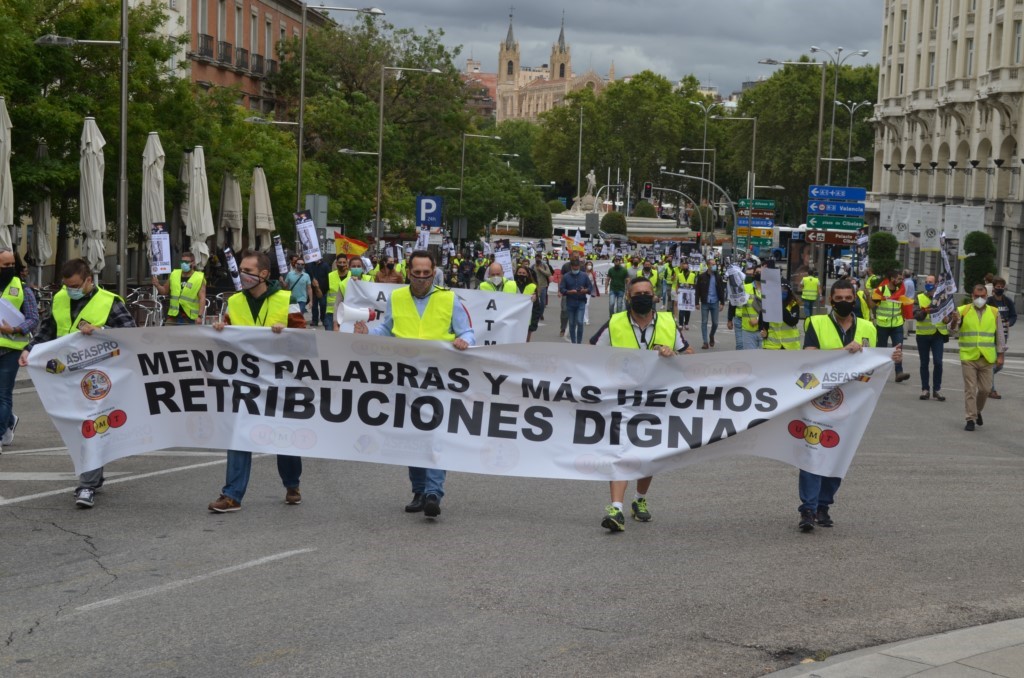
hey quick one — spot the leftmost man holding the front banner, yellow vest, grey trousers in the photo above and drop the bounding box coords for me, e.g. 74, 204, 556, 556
18, 259, 135, 508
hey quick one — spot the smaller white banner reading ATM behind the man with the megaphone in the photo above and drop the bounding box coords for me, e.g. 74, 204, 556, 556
341, 281, 534, 346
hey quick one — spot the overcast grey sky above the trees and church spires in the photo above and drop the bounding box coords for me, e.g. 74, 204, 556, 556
350, 0, 884, 94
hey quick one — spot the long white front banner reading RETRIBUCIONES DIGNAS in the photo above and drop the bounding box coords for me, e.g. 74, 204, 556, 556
29, 326, 892, 480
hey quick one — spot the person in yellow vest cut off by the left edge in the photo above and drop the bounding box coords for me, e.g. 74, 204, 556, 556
0, 247, 39, 454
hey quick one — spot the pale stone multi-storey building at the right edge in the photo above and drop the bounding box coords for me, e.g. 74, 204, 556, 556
872, 0, 1024, 290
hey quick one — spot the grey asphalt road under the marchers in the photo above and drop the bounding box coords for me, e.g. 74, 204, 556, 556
0, 268, 1024, 676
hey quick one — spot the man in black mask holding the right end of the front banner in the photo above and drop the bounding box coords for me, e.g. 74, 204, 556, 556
798, 279, 903, 533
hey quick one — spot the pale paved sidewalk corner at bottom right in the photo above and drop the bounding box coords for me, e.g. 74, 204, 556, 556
769, 619, 1024, 678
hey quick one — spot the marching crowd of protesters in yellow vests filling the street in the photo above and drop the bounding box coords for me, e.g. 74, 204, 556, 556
0, 244, 1017, 532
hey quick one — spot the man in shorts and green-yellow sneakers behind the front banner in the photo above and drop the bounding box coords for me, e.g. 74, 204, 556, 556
590, 278, 693, 533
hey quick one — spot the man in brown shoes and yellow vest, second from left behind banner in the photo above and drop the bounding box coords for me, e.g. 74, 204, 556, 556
207, 251, 305, 513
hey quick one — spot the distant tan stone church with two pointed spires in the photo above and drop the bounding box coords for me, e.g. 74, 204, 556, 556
495, 15, 615, 122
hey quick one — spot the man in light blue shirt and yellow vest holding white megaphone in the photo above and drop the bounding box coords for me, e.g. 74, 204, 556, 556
355, 250, 475, 518
